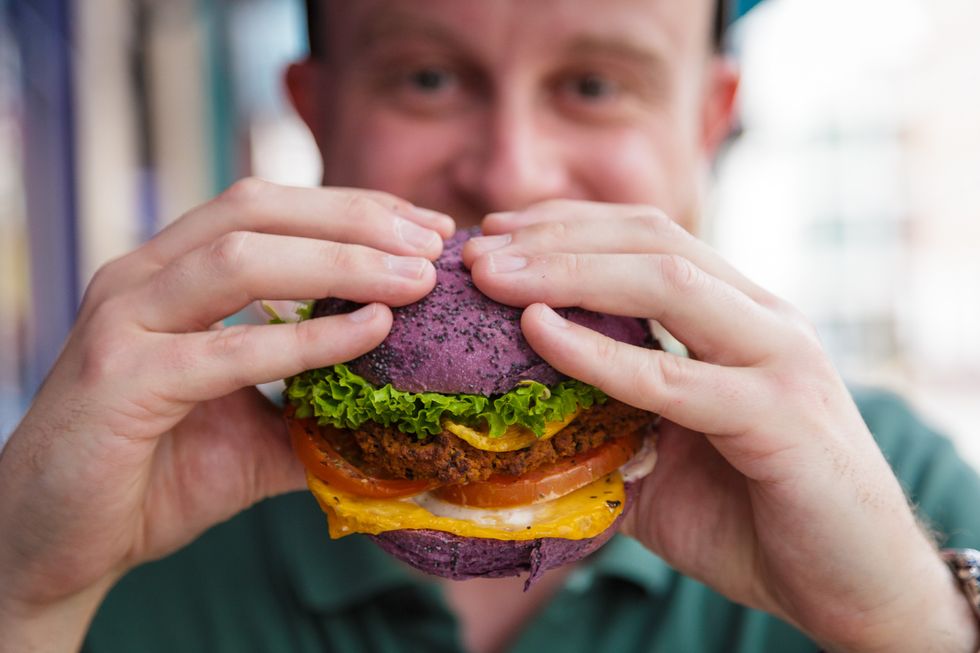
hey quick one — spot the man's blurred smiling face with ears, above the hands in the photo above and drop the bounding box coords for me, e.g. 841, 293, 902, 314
289, 0, 735, 228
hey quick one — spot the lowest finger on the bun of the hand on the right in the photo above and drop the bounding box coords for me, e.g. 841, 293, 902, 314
521, 304, 759, 433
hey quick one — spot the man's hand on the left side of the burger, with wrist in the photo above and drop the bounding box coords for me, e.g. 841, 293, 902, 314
0, 180, 454, 650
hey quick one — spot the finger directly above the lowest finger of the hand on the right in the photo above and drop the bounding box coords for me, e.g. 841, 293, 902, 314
473, 250, 787, 365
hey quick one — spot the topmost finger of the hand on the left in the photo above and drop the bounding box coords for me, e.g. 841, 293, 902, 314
144, 178, 455, 264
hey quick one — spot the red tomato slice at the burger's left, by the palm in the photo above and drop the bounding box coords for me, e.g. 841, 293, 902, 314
286, 409, 438, 499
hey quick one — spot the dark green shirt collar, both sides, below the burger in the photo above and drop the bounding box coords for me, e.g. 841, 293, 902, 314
259, 492, 674, 612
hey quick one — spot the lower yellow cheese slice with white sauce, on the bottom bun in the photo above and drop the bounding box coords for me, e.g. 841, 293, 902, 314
306, 471, 626, 540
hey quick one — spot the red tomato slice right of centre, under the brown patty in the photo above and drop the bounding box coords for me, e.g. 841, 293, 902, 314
432, 432, 643, 508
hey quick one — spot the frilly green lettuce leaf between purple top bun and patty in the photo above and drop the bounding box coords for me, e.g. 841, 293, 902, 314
286, 365, 606, 440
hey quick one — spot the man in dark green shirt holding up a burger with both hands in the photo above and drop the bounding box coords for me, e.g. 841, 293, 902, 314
0, 0, 980, 651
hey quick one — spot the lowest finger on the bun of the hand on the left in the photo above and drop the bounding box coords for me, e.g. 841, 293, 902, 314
154, 304, 392, 402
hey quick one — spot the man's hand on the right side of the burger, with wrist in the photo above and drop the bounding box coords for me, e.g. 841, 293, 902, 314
464, 201, 977, 651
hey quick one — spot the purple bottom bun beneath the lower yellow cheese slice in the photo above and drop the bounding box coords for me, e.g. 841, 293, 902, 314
371, 483, 636, 591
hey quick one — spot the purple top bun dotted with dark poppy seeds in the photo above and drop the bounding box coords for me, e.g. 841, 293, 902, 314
313, 228, 651, 396
